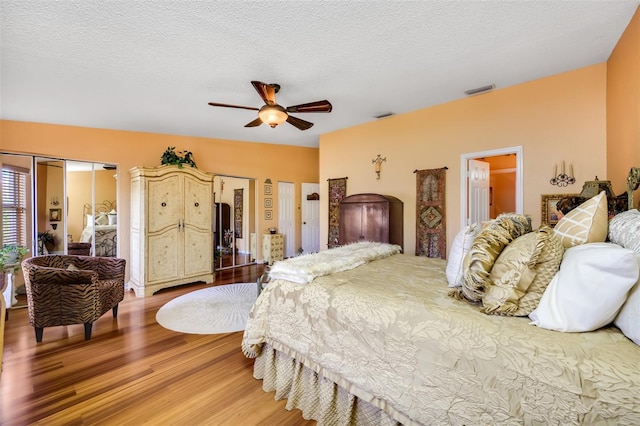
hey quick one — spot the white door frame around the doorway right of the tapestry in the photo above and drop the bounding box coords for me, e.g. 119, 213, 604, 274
460, 146, 524, 229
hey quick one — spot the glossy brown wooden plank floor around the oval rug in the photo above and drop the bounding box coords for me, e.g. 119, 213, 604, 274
0, 265, 315, 426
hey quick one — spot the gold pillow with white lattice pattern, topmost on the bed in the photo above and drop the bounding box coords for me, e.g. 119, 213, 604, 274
553, 191, 609, 248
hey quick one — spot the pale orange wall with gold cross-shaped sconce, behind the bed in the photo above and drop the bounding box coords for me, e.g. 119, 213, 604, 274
320, 63, 617, 254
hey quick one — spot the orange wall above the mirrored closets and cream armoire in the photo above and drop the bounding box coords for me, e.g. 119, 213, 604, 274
0, 120, 318, 274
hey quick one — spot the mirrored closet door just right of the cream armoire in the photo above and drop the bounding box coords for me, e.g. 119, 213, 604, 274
213, 175, 257, 269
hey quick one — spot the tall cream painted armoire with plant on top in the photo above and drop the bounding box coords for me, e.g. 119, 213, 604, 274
129, 165, 214, 296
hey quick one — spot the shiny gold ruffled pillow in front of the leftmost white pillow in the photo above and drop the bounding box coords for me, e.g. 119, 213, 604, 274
458, 213, 531, 302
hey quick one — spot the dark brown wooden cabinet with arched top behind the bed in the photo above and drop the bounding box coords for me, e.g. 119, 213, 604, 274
338, 194, 404, 247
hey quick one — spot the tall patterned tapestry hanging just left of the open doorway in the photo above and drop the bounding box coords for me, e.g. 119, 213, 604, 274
415, 167, 447, 259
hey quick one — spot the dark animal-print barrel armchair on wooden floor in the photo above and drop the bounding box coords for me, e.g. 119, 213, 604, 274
22, 255, 126, 342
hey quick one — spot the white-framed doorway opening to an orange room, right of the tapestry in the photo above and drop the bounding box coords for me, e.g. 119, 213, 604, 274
460, 146, 524, 227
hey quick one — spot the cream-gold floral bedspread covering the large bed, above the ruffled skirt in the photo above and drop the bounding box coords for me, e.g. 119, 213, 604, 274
242, 254, 640, 424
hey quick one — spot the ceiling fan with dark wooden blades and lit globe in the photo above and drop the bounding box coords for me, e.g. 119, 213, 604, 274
209, 80, 333, 130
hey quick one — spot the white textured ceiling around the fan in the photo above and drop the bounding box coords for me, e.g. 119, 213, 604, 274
0, 0, 640, 147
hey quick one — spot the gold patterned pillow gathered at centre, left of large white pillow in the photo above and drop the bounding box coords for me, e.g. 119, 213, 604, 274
482, 225, 564, 316
